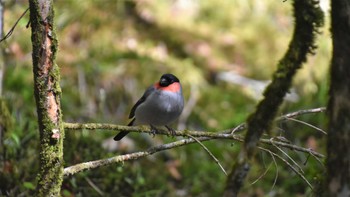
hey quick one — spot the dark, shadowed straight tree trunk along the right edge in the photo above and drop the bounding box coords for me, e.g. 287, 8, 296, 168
325, 0, 350, 196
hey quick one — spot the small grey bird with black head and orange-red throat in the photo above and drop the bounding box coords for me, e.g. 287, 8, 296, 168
113, 74, 184, 141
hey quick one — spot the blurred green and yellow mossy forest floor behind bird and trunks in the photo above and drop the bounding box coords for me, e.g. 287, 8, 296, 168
0, 0, 331, 196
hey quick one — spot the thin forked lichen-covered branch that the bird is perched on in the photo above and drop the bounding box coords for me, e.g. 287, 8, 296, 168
64, 107, 325, 176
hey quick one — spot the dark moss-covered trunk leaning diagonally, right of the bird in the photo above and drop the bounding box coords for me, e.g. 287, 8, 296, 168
225, 0, 323, 196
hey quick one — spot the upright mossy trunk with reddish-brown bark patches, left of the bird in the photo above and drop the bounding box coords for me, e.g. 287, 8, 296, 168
29, 0, 64, 196
